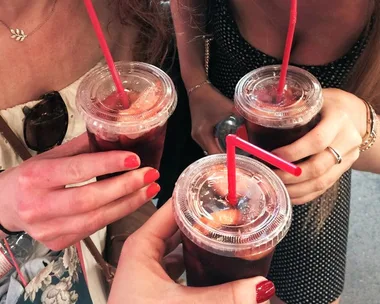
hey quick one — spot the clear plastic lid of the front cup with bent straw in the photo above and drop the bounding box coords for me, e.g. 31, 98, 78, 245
173, 154, 292, 259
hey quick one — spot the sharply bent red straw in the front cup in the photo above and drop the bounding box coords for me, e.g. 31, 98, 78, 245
226, 134, 302, 206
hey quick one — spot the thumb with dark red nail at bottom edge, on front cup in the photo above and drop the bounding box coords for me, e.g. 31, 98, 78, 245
183, 277, 276, 304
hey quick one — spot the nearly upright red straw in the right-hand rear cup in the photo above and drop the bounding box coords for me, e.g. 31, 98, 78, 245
277, 0, 297, 101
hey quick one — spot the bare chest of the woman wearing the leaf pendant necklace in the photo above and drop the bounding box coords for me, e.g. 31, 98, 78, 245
0, 2, 136, 109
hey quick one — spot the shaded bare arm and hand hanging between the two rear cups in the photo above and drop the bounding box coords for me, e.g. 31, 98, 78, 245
171, 0, 233, 154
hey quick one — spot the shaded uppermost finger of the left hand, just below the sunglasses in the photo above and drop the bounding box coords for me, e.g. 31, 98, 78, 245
37, 133, 90, 158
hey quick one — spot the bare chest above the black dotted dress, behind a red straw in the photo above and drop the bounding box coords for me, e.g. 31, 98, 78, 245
217, 0, 368, 65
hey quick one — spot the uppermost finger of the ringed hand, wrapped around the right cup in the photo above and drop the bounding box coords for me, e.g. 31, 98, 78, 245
272, 108, 346, 162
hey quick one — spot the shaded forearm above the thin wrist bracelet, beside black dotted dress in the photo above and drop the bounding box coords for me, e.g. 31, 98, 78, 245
170, 0, 207, 89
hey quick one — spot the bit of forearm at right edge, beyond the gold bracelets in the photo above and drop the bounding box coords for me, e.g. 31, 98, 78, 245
353, 115, 380, 174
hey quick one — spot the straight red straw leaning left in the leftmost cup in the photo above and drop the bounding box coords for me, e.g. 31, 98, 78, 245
83, 0, 129, 108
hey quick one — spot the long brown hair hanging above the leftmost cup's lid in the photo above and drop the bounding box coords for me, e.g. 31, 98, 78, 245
109, 0, 173, 66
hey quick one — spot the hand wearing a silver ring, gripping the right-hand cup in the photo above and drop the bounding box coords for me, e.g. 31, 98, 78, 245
273, 89, 366, 205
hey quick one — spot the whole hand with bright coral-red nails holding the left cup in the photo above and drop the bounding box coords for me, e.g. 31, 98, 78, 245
0, 134, 159, 250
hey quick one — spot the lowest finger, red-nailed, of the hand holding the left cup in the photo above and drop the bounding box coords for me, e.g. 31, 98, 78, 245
28, 183, 160, 244
